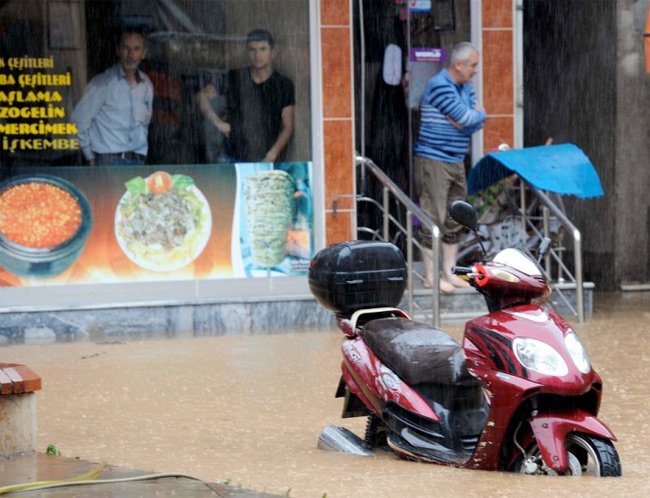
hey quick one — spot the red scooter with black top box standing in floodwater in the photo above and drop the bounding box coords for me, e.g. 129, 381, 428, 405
309, 202, 621, 476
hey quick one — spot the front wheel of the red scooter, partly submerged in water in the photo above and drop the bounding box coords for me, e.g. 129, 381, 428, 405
512, 432, 622, 477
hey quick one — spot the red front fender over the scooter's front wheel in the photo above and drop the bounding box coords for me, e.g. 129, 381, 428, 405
529, 408, 616, 472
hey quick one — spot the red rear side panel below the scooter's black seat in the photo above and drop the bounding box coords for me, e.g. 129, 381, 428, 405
341, 337, 440, 422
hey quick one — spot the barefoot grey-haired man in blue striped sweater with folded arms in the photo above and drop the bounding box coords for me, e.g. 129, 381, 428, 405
414, 42, 485, 292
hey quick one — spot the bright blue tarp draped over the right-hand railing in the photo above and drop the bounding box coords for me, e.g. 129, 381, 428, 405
467, 144, 603, 199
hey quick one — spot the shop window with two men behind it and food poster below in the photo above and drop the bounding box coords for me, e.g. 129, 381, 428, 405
0, 0, 314, 287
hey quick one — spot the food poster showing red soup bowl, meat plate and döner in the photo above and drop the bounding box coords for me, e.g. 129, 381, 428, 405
0, 163, 313, 287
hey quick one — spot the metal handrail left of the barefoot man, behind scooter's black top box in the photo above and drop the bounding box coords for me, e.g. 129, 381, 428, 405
356, 156, 441, 327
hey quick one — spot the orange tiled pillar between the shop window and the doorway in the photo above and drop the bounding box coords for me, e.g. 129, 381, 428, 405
320, 0, 356, 245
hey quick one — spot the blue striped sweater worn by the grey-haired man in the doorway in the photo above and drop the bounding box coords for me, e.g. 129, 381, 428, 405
415, 69, 485, 163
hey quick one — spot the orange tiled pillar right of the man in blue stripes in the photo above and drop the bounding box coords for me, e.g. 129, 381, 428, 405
481, 0, 515, 152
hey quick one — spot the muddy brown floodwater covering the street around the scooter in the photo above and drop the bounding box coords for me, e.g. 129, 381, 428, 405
0, 293, 650, 498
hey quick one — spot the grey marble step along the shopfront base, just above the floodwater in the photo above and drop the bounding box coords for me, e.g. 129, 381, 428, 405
0, 283, 593, 344
